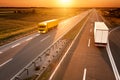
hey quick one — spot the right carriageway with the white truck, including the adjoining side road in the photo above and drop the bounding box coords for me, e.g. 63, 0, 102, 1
49, 10, 120, 80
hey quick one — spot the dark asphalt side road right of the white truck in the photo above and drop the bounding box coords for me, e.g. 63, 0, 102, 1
109, 27, 120, 80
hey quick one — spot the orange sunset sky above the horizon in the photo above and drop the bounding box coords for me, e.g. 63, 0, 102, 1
0, 0, 120, 7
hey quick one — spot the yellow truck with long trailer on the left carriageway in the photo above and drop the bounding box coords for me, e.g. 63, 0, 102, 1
38, 19, 59, 33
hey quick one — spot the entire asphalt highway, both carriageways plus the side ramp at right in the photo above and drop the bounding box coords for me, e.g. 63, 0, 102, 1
0, 9, 120, 80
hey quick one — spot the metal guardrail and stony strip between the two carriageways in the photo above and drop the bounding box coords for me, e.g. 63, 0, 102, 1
10, 39, 67, 80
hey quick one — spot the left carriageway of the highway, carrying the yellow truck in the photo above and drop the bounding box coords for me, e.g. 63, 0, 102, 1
0, 11, 89, 80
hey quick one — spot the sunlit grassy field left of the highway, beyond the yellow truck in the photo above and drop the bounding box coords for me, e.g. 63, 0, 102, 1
0, 8, 83, 46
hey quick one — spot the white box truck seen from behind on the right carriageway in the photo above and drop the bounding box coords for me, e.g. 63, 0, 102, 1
94, 22, 109, 47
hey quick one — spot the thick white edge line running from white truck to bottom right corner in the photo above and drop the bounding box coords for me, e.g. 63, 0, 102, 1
106, 41, 120, 80
